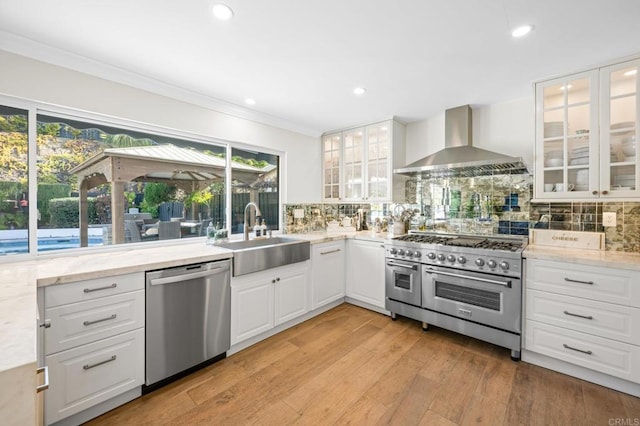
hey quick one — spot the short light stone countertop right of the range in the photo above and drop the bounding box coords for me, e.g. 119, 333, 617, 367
523, 244, 640, 271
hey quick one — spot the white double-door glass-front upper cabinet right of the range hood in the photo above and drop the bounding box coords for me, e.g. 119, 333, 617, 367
535, 56, 640, 199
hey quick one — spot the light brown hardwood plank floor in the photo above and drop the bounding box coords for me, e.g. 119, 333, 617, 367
89, 304, 640, 426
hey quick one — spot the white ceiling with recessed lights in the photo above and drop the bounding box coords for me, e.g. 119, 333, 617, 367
0, 0, 640, 135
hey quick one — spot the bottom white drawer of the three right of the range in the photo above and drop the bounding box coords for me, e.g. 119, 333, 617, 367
524, 320, 640, 383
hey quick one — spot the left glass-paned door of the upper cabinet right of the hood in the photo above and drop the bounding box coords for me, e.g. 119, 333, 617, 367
536, 71, 599, 198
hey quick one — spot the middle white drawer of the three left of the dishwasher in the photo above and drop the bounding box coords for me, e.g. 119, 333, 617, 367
44, 290, 144, 354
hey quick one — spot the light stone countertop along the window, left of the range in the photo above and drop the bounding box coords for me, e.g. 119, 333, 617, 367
0, 231, 388, 376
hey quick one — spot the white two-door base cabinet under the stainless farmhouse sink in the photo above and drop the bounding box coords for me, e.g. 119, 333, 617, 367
231, 262, 309, 345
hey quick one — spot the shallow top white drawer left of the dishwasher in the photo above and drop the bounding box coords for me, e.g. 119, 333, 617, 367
44, 272, 144, 308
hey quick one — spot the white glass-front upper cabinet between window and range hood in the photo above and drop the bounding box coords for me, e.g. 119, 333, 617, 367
322, 120, 406, 201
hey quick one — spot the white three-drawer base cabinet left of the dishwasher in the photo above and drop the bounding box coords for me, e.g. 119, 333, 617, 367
41, 272, 145, 424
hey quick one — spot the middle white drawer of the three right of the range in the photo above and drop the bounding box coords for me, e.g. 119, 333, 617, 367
526, 289, 640, 345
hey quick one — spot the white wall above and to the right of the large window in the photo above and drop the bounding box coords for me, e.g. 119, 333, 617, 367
0, 50, 321, 203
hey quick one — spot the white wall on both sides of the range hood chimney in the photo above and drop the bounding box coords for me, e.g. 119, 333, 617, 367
406, 98, 535, 171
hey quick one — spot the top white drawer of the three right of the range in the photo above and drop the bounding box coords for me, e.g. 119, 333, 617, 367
526, 259, 640, 308
